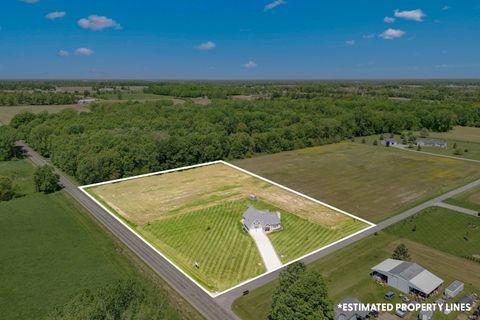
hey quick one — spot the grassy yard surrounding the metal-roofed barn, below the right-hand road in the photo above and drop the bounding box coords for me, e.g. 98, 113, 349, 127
233, 208, 480, 320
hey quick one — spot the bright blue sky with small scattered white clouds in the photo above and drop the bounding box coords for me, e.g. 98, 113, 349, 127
0, 0, 480, 79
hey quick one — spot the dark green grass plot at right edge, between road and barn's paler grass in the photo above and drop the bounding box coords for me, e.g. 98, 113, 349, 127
389, 207, 480, 257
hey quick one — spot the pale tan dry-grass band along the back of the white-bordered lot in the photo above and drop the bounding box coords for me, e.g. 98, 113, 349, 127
93, 164, 350, 227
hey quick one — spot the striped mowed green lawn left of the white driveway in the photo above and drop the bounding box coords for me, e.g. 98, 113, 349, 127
139, 201, 265, 291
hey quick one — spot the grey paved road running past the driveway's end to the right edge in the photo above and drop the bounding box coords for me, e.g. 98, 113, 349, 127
215, 179, 480, 309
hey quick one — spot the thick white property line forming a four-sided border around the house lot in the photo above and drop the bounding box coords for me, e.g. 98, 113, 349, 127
78, 160, 376, 298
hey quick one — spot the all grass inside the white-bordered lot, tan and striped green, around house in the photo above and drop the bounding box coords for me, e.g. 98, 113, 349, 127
88, 164, 368, 291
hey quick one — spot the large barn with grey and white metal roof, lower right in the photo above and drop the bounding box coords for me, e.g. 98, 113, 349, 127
372, 259, 443, 297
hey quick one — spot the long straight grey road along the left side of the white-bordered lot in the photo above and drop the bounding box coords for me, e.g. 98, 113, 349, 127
18, 143, 237, 320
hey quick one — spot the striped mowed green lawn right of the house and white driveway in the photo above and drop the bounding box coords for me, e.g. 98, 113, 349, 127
268, 213, 368, 263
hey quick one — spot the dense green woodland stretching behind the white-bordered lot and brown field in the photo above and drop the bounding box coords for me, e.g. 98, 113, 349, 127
4, 91, 480, 183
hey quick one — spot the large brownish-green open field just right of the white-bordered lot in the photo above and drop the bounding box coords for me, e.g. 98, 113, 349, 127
234, 142, 480, 222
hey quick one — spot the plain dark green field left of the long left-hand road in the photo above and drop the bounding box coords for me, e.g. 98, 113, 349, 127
0, 160, 200, 319
